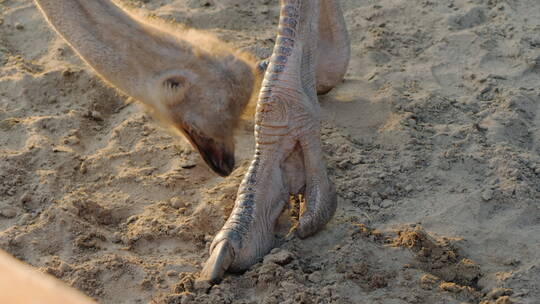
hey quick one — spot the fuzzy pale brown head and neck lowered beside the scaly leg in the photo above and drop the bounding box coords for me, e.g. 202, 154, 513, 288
36, 0, 258, 175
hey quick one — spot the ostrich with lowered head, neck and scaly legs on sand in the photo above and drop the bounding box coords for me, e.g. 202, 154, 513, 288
35, 0, 350, 284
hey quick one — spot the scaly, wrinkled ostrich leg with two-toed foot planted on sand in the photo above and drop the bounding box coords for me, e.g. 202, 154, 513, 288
199, 0, 348, 284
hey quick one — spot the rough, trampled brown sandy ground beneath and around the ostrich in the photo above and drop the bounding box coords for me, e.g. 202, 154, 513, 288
0, 0, 540, 304
